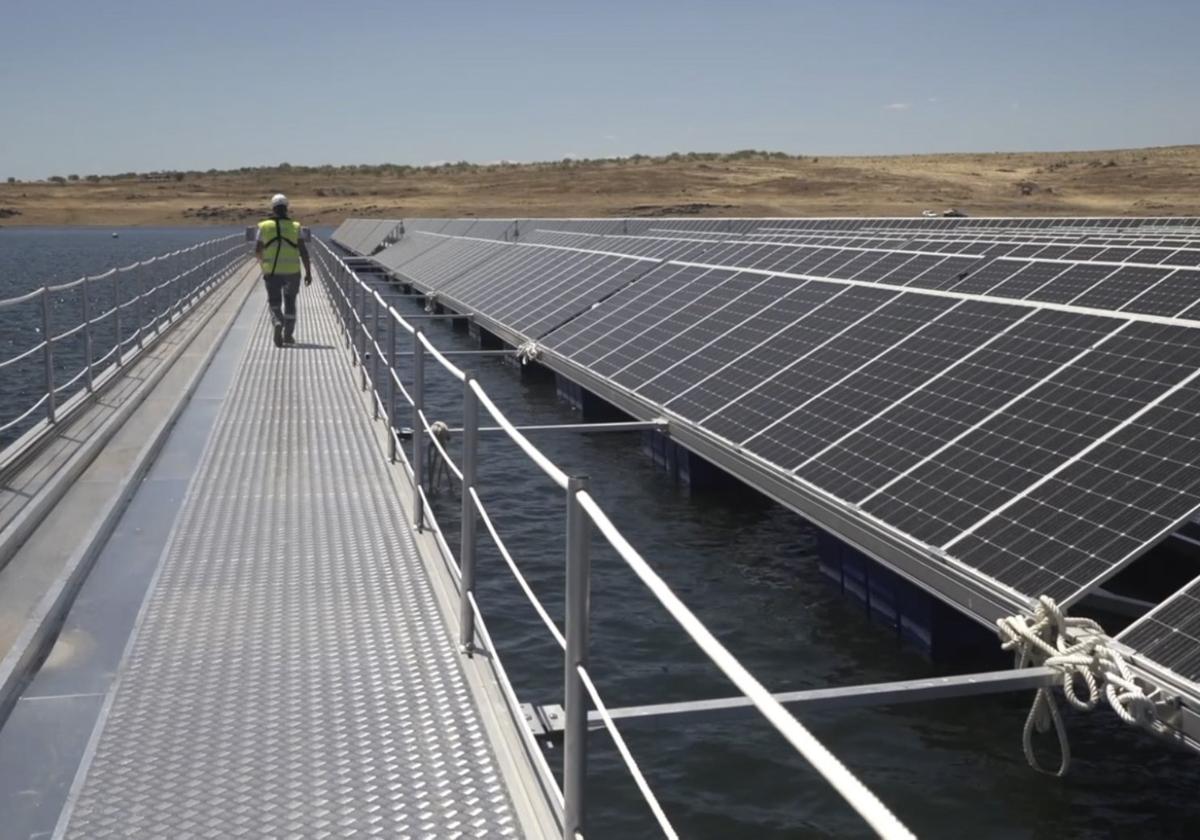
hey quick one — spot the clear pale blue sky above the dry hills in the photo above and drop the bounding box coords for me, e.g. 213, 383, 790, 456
0, 0, 1200, 179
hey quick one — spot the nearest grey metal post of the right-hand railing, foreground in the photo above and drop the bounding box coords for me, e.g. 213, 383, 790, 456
563, 476, 592, 840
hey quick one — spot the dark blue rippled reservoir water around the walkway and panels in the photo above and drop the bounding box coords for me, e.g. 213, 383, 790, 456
0, 228, 1200, 840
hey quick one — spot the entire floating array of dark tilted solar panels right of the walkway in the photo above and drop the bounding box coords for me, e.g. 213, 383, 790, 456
333, 218, 1200, 638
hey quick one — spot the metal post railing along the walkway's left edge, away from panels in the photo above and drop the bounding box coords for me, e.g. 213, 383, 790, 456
0, 234, 247, 466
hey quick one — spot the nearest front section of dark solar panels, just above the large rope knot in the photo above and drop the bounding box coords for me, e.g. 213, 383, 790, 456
542, 263, 1200, 598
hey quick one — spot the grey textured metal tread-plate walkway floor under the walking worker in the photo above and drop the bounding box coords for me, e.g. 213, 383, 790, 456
48, 273, 522, 838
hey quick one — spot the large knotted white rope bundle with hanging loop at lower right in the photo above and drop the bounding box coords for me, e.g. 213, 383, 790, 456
996, 595, 1166, 776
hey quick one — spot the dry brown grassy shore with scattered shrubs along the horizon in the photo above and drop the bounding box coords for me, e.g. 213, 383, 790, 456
0, 145, 1200, 227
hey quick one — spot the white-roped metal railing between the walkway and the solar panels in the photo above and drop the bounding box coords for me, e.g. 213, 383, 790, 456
314, 241, 913, 840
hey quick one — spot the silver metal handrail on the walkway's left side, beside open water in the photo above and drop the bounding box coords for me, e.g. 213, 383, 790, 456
0, 234, 246, 463
